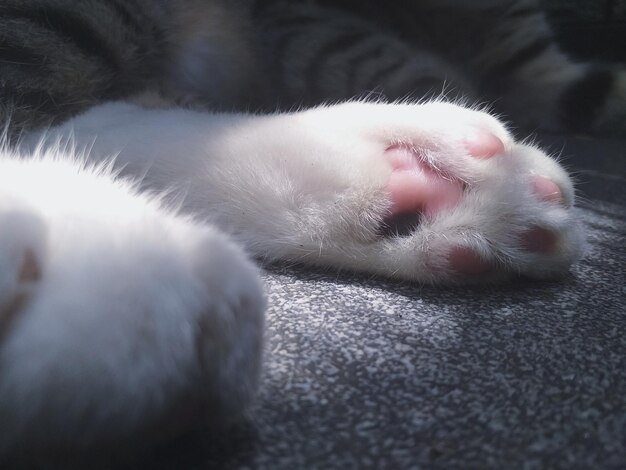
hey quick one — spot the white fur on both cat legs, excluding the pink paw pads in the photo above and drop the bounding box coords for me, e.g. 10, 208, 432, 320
0, 103, 582, 451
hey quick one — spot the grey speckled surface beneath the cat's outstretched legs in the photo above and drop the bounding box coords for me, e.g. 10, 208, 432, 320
147, 134, 626, 469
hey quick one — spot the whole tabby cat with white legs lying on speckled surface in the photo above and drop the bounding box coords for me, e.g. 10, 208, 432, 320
0, 0, 626, 462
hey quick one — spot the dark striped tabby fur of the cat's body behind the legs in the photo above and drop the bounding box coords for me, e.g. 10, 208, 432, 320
0, 0, 626, 135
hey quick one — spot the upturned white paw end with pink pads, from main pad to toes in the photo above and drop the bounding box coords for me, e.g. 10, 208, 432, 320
368, 104, 582, 282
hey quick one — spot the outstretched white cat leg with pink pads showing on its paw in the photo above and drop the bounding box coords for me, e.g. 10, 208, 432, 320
34, 103, 582, 282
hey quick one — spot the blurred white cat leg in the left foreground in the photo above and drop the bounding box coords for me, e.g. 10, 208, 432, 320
0, 151, 265, 456
